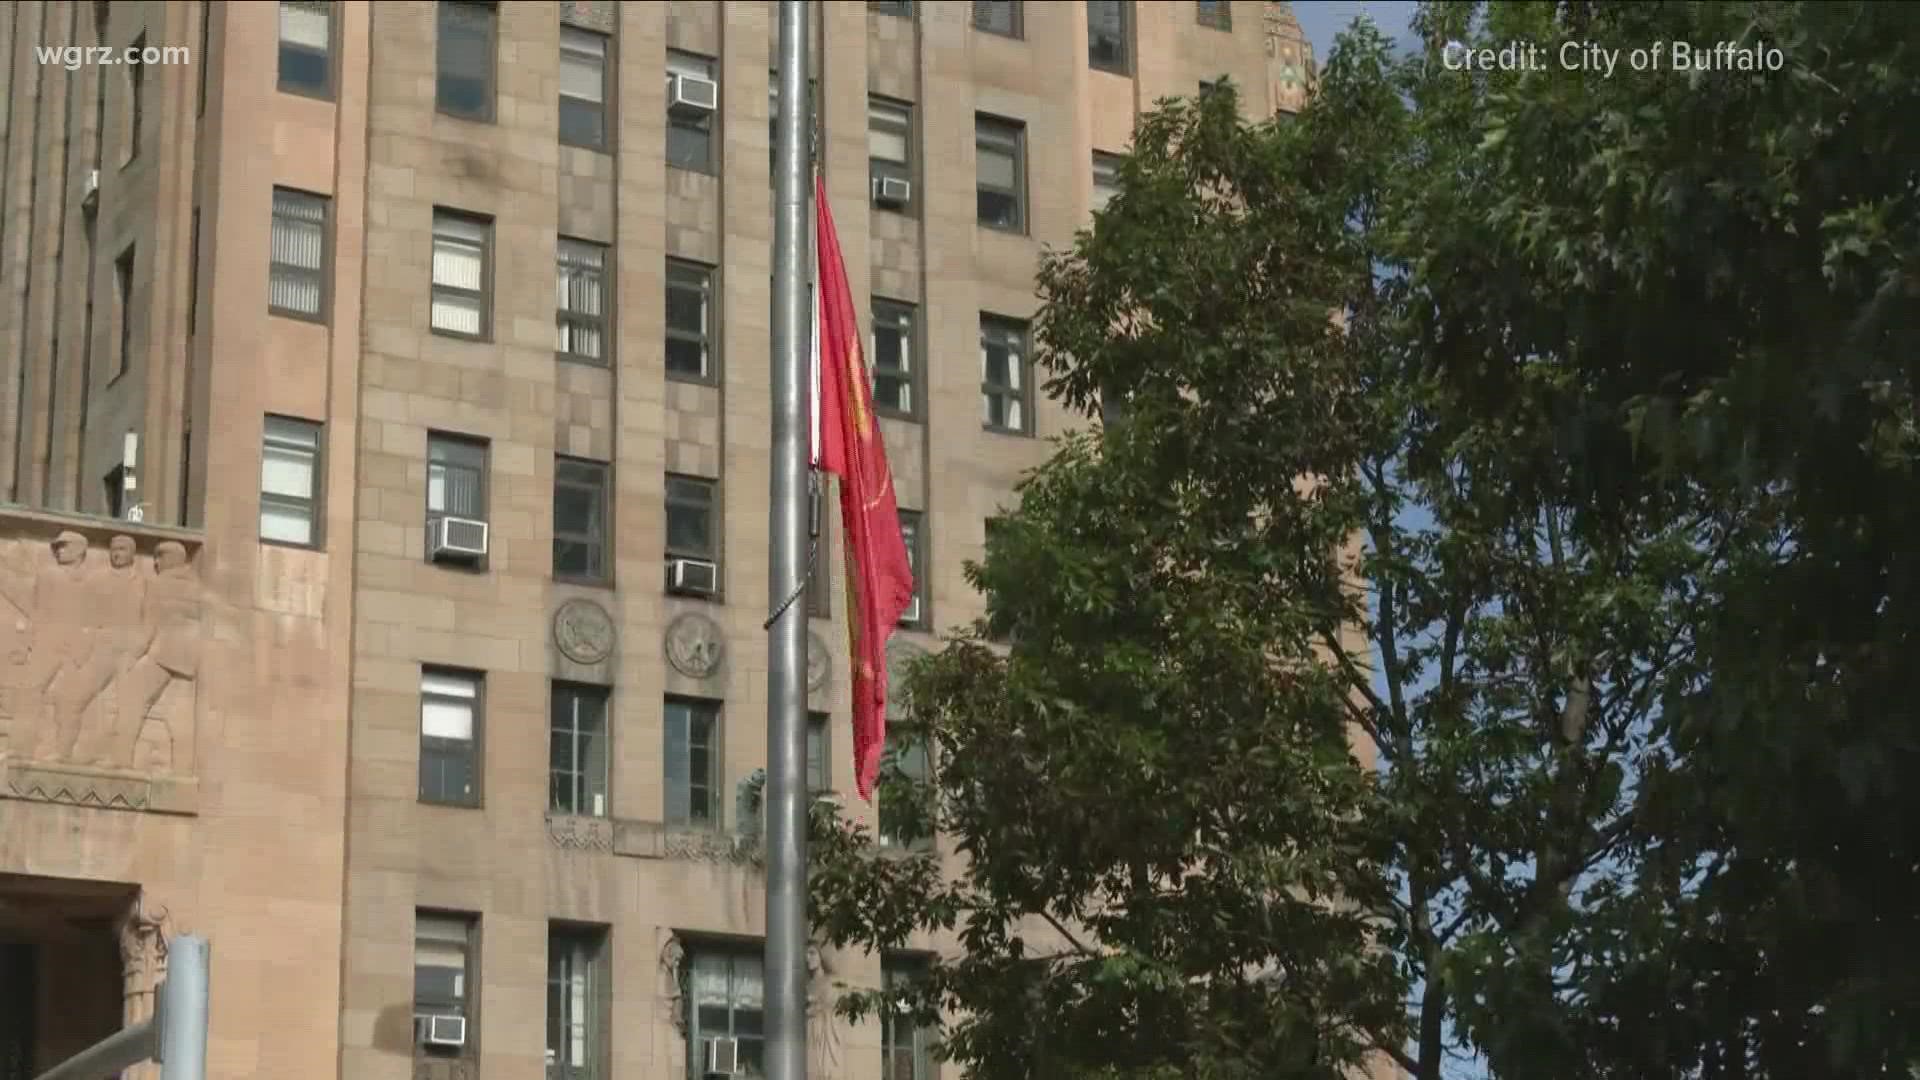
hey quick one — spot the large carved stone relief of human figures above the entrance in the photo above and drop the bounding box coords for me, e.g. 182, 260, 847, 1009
0, 530, 202, 776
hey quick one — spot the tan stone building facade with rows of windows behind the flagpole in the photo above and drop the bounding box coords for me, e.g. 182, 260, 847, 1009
0, 0, 1311, 1080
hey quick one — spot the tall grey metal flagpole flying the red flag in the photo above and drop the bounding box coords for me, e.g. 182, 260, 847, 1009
764, 0, 812, 1080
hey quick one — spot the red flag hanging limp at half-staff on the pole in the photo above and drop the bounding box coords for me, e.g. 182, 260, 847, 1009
812, 177, 914, 801
